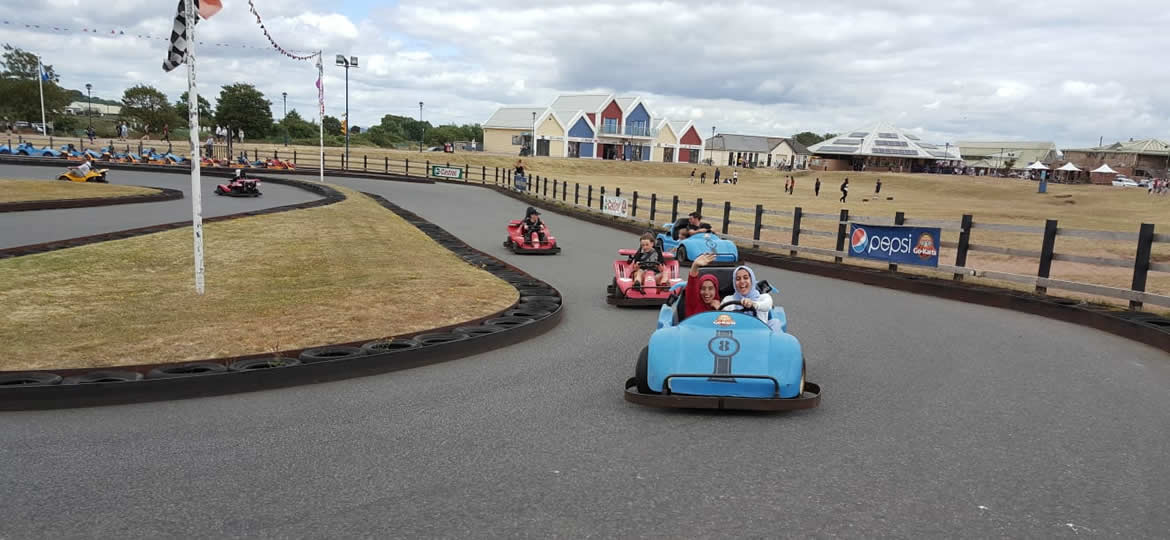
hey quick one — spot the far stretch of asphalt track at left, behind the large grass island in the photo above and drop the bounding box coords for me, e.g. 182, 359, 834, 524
0, 165, 319, 249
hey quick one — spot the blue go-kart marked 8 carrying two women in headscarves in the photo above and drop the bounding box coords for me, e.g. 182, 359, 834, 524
625, 268, 820, 410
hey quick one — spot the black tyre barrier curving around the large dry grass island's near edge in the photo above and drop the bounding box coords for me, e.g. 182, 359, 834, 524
0, 181, 563, 410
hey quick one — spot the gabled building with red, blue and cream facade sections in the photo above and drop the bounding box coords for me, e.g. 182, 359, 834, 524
483, 94, 703, 164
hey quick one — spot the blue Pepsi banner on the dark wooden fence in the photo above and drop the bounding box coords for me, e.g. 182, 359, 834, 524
848, 223, 940, 266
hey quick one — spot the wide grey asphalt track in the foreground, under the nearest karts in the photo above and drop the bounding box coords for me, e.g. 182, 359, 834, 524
0, 170, 1170, 538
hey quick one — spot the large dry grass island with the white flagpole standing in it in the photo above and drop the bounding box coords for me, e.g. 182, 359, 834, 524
0, 187, 517, 371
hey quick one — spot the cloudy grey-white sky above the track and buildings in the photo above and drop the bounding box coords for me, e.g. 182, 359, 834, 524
0, 0, 1170, 147
